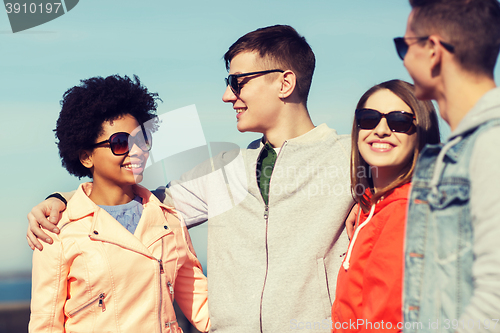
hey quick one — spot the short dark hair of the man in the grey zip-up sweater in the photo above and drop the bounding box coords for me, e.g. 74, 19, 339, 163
224, 25, 316, 103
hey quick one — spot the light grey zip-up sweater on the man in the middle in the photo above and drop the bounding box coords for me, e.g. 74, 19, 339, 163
166, 124, 353, 333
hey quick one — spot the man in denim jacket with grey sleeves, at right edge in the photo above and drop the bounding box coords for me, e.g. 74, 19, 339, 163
394, 0, 500, 332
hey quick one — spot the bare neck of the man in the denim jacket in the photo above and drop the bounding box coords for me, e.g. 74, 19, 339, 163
434, 67, 496, 131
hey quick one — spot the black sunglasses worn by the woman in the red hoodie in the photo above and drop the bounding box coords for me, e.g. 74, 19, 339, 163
355, 109, 415, 133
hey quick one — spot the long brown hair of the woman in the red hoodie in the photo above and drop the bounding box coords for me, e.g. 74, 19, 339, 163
351, 80, 440, 210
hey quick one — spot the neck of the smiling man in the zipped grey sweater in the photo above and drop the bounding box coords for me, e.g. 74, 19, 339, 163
263, 103, 314, 148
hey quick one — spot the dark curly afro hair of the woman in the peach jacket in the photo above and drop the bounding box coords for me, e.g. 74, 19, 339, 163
54, 75, 161, 178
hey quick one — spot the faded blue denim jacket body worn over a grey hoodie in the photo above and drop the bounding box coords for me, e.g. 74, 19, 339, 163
403, 90, 500, 332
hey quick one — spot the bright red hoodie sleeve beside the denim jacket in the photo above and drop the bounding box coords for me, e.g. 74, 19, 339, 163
361, 199, 408, 332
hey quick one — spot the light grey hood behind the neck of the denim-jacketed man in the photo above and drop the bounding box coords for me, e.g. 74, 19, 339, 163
448, 87, 500, 141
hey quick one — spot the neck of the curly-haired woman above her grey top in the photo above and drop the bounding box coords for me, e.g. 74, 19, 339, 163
89, 179, 135, 206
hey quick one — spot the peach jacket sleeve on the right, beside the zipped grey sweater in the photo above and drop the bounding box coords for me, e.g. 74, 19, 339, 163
175, 223, 210, 332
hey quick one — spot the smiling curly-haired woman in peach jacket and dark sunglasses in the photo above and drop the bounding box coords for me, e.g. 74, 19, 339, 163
29, 75, 210, 333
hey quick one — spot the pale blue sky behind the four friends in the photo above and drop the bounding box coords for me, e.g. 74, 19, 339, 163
0, 0, 499, 273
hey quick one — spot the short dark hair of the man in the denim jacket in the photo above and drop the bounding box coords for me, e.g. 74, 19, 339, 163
410, 0, 500, 77
